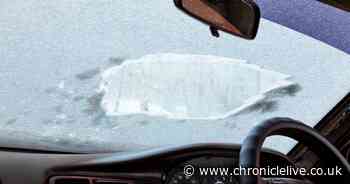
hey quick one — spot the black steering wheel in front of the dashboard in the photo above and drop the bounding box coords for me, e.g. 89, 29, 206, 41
239, 118, 350, 184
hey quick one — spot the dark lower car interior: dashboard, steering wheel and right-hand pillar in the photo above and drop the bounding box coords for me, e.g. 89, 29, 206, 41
0, 95, 350, 184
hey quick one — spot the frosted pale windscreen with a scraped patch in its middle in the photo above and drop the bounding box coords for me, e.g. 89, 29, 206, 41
0, 0, 350, 152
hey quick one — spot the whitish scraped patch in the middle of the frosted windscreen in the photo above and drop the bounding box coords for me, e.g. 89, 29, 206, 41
100, 54, 294, 119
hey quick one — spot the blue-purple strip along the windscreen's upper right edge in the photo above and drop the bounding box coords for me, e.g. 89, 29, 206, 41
257, 0, 350, 54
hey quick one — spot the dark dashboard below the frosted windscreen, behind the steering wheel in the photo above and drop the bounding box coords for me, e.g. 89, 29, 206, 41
0, 144, 293, 184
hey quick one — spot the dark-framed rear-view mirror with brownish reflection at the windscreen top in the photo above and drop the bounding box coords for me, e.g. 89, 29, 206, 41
174, 0, 260, 39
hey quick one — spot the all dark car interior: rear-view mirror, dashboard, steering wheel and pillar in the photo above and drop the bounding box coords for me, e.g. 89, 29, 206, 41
0, 0, 350, 184
